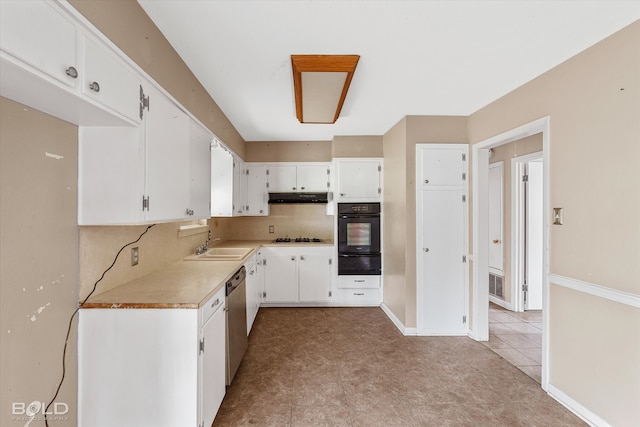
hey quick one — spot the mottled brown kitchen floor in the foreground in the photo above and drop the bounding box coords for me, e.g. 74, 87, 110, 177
213, 307, 584, 427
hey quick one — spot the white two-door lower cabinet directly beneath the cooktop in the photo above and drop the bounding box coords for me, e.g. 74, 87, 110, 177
262, 246, 333, 303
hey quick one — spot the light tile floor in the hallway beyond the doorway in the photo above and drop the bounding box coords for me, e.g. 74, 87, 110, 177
483, 303, 542, 384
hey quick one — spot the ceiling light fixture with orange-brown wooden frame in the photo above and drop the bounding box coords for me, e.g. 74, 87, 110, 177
291, 55, 360, 123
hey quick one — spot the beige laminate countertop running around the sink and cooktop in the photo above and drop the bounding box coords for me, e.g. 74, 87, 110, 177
82, 240, 333, 309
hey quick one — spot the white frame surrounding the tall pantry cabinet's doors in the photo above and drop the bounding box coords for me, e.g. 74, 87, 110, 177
415, 143, 470, 336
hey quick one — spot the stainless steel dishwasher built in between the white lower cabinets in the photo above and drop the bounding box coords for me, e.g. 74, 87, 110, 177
225, 266, 249, 385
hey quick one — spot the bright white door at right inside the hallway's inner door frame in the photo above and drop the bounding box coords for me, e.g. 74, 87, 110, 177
525, 160, 544, 310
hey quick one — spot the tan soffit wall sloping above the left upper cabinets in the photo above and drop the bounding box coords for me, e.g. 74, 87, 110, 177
69, 0, 245, 159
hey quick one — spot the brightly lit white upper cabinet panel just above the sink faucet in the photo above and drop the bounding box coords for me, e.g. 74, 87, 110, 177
211, 148, 233, 216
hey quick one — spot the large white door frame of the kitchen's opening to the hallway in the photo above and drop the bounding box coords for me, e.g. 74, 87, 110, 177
469, 116, 551, 390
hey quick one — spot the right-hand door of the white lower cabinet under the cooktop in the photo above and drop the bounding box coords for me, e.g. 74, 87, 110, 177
298, 254, 331, 301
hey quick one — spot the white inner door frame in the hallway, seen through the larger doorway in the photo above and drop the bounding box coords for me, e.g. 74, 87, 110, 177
511, 151, 546, 312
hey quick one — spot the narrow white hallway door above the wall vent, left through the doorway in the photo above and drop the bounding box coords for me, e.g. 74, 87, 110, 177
489, 162, 504, 276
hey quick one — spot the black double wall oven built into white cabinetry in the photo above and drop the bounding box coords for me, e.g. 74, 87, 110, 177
338, 203, 382, 276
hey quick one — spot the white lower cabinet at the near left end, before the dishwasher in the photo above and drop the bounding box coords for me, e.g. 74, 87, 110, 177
78, 287, 225, 427
